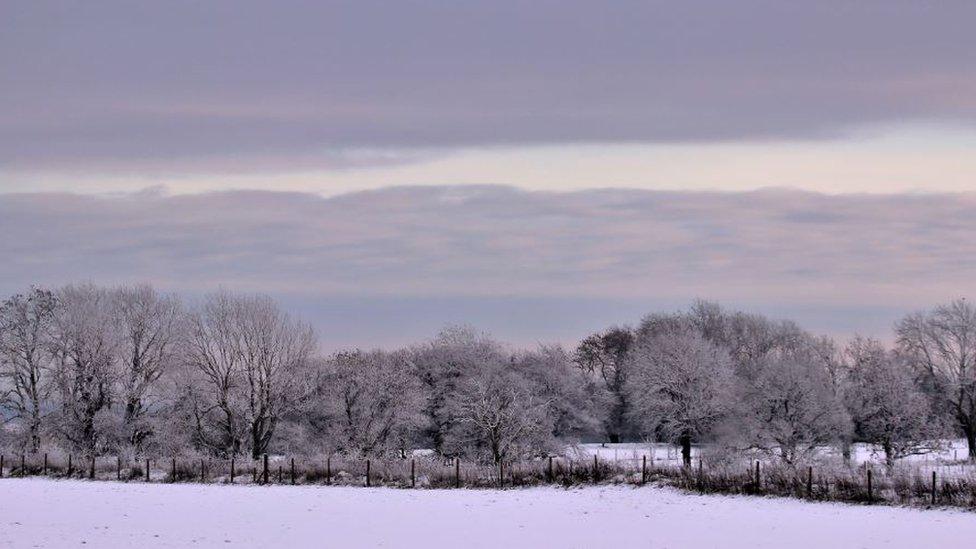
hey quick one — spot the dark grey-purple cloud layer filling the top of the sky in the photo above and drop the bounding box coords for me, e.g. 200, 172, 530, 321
0, 0, 976, 173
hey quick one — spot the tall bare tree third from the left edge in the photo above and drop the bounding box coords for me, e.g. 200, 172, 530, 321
113, 285, 184, 453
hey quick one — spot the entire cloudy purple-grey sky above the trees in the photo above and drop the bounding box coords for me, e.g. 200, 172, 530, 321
0, 0, 976, 348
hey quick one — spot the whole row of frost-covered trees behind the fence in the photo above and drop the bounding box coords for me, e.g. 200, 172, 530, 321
0, 284, 976, 465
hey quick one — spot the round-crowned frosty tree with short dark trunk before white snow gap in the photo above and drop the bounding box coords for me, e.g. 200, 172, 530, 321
626, 331, 733, 465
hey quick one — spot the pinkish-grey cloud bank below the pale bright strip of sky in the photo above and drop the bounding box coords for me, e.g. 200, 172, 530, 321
0, 186, 976, 306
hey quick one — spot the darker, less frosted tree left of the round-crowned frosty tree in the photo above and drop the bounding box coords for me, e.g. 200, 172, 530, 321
573, 327, 634, 442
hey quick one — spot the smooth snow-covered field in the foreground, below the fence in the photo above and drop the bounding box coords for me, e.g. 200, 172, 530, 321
0, 479, 976, 549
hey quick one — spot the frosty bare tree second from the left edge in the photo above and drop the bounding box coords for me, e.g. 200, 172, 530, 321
51, 285, 119, 455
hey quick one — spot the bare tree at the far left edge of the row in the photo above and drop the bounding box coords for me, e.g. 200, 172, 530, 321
0, 288, 58, 452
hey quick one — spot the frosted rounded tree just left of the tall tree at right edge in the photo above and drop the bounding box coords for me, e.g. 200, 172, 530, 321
844, 337, 942, 468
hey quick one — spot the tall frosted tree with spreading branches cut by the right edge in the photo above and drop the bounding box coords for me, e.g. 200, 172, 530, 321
896, 299, 976, 460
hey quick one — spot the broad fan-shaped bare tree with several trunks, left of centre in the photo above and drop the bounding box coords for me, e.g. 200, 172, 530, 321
186, 293, 316, 459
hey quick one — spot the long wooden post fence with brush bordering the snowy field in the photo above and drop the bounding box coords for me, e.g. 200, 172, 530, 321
0, 454, 976, 507
